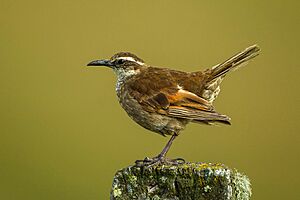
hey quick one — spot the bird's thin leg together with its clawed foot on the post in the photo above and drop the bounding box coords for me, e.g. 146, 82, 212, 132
135, 134, 184, 166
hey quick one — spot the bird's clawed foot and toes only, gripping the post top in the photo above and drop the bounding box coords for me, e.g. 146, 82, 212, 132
135, 155, 185, 167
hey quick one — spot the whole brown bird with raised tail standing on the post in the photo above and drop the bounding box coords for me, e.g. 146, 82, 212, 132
87, 45, 260, 166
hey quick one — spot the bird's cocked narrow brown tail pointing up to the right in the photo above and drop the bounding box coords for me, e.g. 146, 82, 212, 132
210, 45, 260, 81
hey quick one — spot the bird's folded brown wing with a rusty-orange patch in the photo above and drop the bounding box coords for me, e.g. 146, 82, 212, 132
129, 68, 230, 123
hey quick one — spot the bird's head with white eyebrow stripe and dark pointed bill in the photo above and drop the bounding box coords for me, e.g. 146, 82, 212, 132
87, 52, 146, 78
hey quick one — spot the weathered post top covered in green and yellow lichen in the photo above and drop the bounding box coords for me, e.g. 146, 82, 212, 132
111, 163, 251, 200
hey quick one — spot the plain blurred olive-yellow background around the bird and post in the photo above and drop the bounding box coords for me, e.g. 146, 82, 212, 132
0, 0, 300, 200
